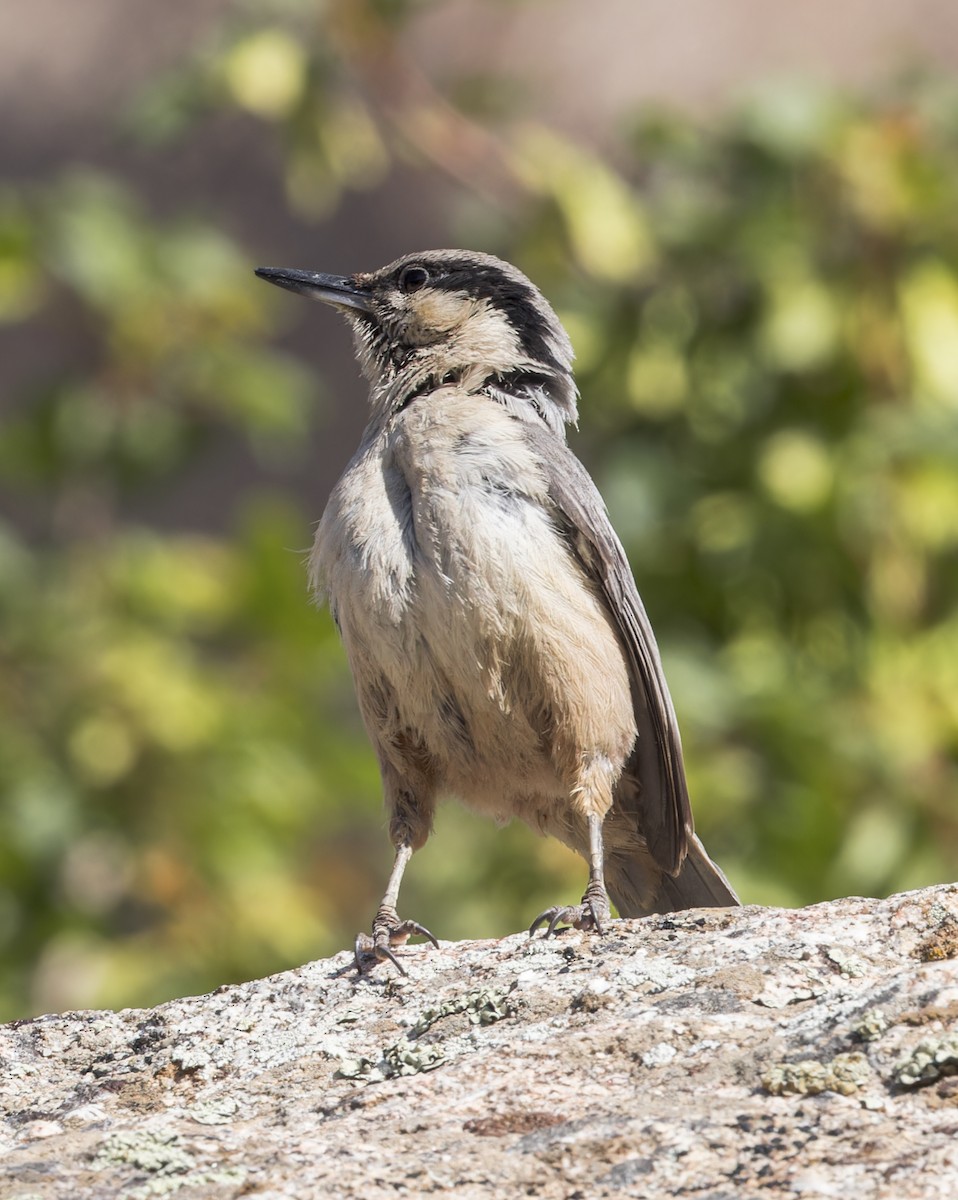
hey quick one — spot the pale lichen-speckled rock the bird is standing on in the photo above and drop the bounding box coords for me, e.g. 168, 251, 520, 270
0, 886, 958, 1200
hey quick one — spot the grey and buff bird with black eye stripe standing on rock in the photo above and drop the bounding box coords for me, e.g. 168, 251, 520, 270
256, 250, 740, 973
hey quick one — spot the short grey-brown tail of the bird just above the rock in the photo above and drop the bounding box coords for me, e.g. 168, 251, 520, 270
606, 834, 741, 917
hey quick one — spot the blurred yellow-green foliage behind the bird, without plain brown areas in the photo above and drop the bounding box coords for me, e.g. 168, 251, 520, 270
0, 0, 958, 1018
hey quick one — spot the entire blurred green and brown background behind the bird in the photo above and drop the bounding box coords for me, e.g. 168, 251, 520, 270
0, 0, 958, 1019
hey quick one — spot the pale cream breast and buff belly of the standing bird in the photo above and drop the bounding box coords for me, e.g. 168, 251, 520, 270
316, 410, 635, 824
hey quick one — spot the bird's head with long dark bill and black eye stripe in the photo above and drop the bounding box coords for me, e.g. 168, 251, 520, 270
256, 250, 576, 434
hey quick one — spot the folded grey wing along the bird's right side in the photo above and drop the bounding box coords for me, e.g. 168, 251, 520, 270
529, 425, 691, 875
